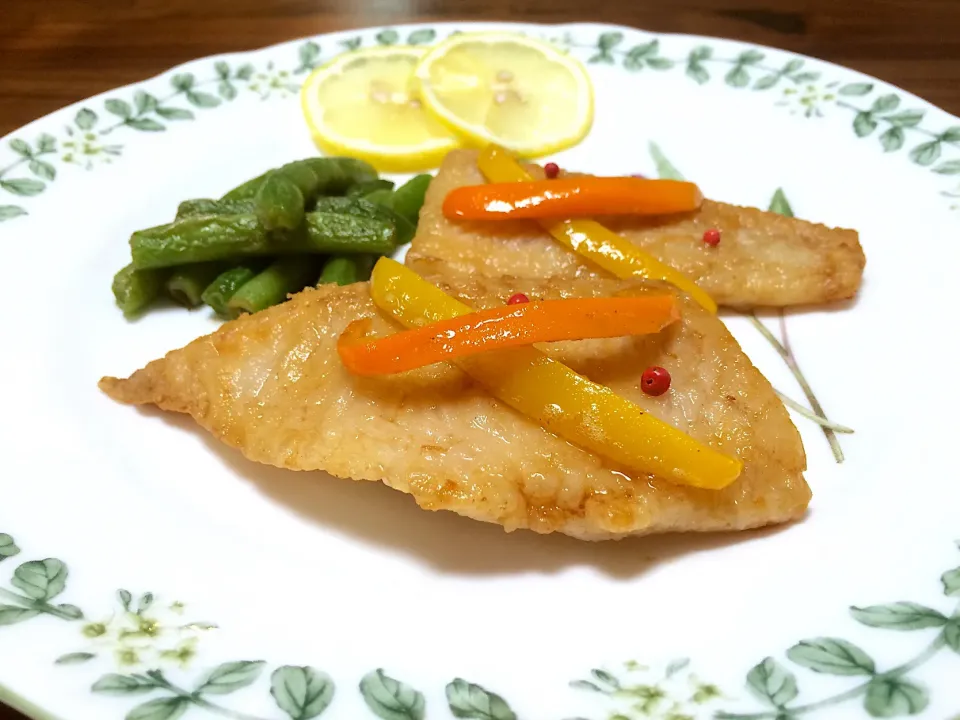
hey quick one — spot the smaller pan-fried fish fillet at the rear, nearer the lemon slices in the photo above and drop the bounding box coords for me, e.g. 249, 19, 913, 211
408, 150, 865, 308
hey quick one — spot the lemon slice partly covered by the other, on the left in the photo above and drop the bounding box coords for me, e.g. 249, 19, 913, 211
300, 46, 460, 172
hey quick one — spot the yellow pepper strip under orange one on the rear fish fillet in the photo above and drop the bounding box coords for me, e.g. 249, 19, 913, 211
479, 145, 717, 313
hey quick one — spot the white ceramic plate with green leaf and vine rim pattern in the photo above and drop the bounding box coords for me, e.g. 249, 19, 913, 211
0, 19, 960, 720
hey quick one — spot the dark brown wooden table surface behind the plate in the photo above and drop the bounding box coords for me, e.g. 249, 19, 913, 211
0, 0, 960, 720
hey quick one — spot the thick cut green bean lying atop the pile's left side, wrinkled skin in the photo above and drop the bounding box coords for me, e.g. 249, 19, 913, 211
130, 214, 273, 270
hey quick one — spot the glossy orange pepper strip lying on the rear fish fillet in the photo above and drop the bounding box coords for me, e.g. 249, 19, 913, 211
443, 175, 703, 220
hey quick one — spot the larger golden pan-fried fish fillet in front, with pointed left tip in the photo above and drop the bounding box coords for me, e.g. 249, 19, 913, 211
100, 262, 810, 540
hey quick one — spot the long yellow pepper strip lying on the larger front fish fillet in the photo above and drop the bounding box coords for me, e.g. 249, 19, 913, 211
370, 257, 743, 490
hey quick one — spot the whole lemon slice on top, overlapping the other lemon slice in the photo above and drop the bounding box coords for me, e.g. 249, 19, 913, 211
417, 32, 593, 157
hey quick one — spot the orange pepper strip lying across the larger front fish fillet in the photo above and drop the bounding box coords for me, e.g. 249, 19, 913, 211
337, 293, 680, 375
